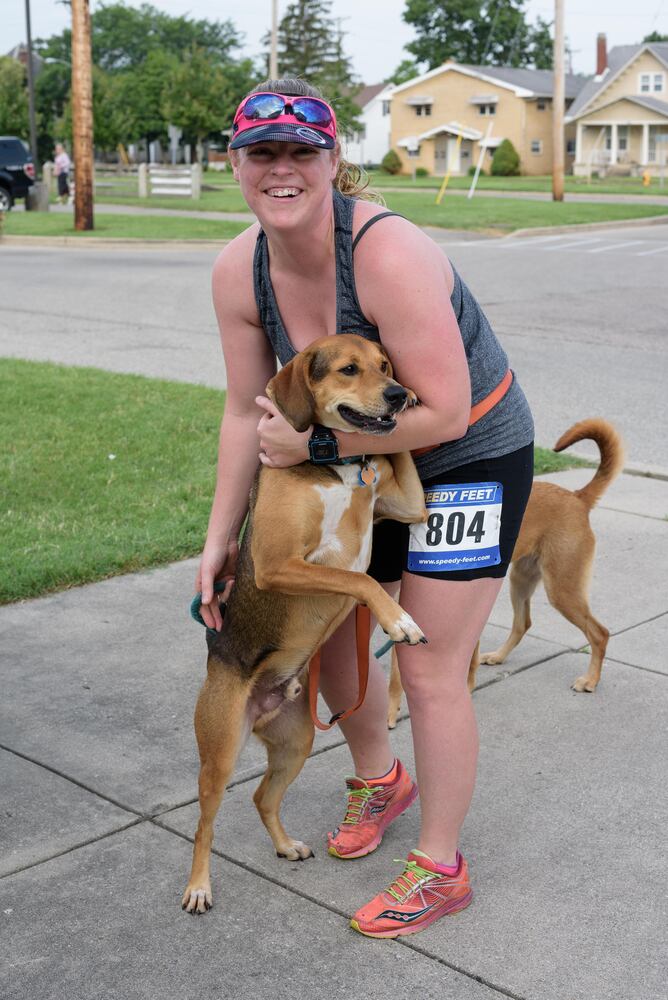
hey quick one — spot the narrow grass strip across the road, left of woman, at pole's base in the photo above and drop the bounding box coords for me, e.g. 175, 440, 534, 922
2, 212, 248, 242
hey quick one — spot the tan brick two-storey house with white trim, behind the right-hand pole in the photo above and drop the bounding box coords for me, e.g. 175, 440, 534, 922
390, 62, 586, 176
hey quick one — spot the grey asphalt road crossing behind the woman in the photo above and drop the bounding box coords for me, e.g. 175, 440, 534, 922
0, 225, 668, 473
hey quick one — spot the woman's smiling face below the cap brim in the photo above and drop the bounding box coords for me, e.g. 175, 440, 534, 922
230, 142, 338, 229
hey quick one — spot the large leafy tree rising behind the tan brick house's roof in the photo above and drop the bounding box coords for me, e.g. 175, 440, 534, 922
403, 0, 551, 69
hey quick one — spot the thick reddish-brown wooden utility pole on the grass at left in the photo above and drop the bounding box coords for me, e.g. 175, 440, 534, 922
72, 0, 93, 230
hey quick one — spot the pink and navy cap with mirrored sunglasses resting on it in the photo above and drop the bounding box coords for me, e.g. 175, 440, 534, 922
229, 92, 336, 149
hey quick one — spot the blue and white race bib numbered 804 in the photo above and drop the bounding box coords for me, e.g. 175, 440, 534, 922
408, 483, 503, 573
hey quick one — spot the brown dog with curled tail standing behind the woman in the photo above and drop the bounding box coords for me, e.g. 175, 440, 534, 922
388, 418, 624, 729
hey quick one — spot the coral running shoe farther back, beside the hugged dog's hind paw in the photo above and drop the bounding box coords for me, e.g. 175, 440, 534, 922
327, 760, 418, 860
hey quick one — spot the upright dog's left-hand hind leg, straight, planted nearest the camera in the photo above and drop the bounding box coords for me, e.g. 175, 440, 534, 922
181, 666, 250, 913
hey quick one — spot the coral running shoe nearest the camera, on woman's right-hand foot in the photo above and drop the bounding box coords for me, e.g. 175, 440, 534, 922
350, 851, 473, 938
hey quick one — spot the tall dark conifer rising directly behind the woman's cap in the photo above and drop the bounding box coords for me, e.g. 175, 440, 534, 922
264, 0, 361, 134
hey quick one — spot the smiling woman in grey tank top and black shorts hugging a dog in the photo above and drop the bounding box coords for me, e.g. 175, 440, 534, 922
191, 79, 533, 937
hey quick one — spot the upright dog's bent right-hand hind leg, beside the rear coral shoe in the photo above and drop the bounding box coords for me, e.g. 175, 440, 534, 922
253, 684, 313, 861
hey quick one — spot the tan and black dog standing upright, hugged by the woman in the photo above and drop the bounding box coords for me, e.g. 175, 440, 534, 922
182, 334, 426, 913
